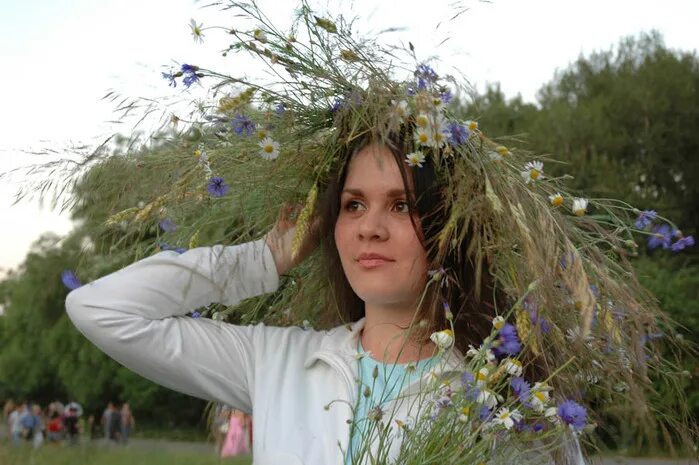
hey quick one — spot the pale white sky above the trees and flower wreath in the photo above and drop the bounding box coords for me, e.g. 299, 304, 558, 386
0, 0, 699, 275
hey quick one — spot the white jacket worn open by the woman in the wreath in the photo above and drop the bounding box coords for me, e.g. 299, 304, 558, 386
66, 240, 581, 465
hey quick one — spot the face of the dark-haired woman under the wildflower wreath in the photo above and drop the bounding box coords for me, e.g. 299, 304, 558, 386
335, 144, 428, 307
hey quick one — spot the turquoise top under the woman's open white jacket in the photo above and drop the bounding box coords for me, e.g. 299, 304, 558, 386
345, 338, 438, 465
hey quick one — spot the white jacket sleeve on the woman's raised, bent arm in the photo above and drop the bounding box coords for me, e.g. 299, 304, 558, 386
66, 240, 279, 412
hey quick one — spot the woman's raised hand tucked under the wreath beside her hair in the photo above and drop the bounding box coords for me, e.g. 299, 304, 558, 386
265, 204, 319, 275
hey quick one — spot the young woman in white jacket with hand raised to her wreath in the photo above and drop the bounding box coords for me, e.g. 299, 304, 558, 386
66, 142, 492, 465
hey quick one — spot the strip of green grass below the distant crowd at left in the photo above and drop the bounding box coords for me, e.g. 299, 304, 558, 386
0, 443, 252, 465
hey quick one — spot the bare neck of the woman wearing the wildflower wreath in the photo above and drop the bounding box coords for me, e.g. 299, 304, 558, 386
359, 307, 435, 363
